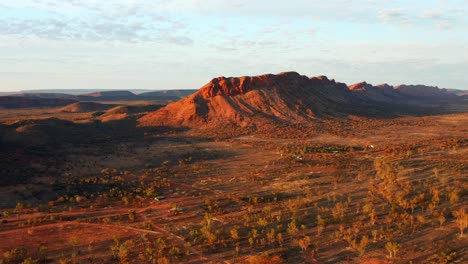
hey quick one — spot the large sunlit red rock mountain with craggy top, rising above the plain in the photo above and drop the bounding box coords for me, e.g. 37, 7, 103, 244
139, 72, 468, 128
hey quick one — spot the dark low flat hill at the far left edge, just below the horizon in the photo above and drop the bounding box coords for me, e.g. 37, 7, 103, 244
0, 96, 76, 109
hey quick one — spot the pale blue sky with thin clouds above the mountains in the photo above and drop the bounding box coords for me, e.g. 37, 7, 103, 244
0, 0, 468, 92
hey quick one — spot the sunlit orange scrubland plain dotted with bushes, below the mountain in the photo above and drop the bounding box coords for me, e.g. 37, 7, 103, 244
0, 114, 468, 263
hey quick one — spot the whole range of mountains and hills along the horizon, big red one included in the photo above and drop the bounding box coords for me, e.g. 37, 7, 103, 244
0, 72, 468, 114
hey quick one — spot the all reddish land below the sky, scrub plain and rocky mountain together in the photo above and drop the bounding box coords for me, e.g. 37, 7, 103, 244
0, 73, 468, 264
